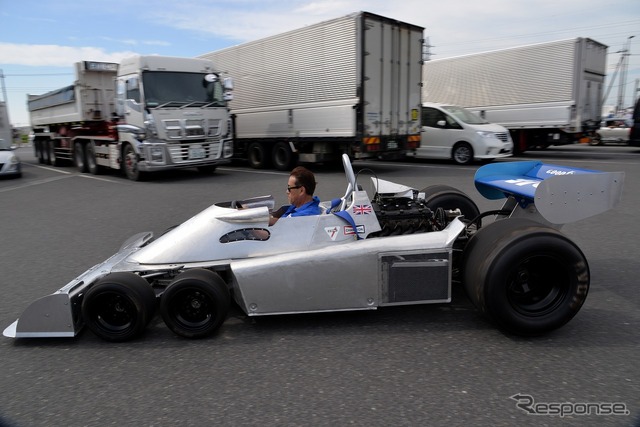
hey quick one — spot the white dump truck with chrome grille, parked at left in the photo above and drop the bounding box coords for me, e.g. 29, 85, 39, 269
27, 56, 233, 181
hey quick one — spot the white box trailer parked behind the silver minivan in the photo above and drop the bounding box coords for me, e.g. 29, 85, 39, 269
423, 38, 607, 152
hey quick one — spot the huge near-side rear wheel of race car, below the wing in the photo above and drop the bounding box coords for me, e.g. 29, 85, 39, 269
462, 218, 589, 336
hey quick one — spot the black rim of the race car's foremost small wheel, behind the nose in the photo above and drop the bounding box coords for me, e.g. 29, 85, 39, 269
90, 292, 138, 336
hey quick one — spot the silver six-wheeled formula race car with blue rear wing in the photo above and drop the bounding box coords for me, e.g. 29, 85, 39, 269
4, 156, 624, 341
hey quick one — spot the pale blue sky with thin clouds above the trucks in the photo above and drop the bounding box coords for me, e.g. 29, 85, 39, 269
0, 0, 640, 126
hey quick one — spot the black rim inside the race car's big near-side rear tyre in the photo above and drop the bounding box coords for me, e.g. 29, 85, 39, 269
507, 255, 570, 316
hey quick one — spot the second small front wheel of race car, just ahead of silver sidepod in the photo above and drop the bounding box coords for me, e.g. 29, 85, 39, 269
160, 269, 231, 338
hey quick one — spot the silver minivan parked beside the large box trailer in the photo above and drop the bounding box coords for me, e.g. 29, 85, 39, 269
415, 102, 513, 165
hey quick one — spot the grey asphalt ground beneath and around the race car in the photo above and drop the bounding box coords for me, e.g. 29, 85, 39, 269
0, 146, 640, 427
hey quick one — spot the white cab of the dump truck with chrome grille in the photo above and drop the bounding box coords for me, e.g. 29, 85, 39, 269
116, 56, 233, 179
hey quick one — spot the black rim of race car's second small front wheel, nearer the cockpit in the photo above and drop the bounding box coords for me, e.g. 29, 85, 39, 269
169, 288, 215, 331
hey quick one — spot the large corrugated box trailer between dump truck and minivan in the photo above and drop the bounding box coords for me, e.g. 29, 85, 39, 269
201, 12, 423, 170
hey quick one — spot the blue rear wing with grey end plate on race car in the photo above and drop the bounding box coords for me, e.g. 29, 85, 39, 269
475, 161, 624, 224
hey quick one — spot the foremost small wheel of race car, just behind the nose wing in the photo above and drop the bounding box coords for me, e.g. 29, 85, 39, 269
82, 272, 156, 342
